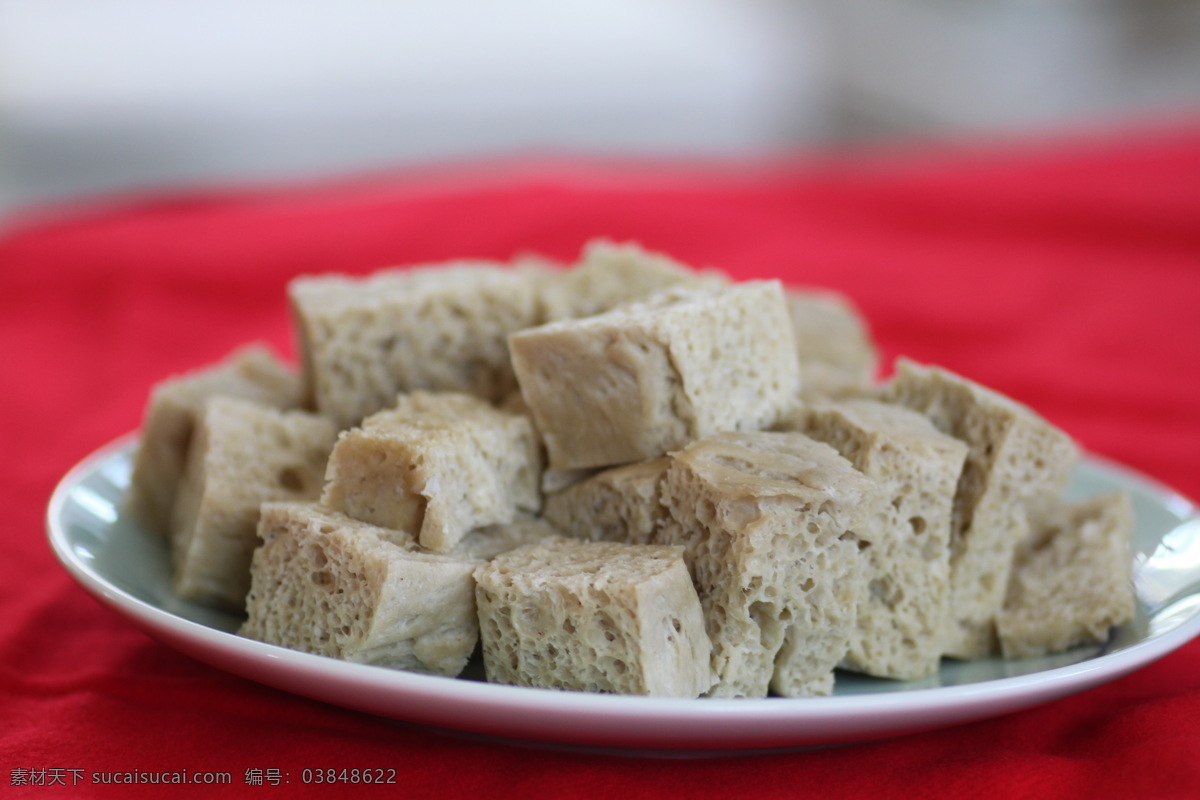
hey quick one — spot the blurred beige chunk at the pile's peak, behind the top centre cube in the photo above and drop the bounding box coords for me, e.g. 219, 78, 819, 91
542, 240, 728, 321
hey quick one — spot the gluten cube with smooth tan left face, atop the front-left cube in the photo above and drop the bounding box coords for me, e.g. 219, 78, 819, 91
322, 391, 541, 553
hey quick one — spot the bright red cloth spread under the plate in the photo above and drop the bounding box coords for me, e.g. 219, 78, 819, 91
0, 130, 1200, 800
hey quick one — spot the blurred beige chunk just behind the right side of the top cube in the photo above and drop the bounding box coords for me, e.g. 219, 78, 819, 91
787, 288, 878, 397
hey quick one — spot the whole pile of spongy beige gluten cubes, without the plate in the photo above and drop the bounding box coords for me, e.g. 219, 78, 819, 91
126, 241, 1134, 697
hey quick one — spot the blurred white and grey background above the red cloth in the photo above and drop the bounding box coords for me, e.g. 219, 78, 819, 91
0, 0, 1200, 215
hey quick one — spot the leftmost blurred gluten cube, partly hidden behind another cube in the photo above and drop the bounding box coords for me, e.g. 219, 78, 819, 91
125, 344, 302, 539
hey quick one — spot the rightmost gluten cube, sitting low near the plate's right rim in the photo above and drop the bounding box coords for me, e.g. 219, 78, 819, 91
996, 492, 1135, 658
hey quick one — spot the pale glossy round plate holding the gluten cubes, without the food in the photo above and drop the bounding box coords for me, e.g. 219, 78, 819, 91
47, 439, 1200, 754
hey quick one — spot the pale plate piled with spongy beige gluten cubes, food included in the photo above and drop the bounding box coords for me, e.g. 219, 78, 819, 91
47, 245, 1200, 753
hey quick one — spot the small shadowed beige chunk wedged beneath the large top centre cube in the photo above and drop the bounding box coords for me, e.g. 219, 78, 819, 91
542, 457, 671, 545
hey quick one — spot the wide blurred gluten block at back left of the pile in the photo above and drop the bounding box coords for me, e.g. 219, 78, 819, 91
288, 261, 542, 428
